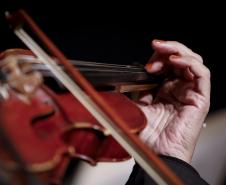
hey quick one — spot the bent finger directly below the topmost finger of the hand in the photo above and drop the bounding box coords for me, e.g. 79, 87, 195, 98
169, 55, 210, 96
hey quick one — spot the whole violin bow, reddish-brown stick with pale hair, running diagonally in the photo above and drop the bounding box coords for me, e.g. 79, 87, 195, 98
6, 10, 184, 185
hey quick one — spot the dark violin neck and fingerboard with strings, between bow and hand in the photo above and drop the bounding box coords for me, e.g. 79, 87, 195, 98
35, 60, 162, 92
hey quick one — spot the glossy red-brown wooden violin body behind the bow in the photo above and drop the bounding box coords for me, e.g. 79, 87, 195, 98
0, 49, 146, 184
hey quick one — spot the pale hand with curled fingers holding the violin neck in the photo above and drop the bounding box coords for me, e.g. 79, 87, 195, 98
139, 40, 210, 163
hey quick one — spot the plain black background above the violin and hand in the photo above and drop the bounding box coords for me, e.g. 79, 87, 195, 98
0, 0, 226, 111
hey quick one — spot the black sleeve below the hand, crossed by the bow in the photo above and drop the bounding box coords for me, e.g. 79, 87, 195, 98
126, 156, 208, 185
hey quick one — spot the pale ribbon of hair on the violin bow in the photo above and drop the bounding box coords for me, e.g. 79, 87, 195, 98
14, 28, 168, 185
